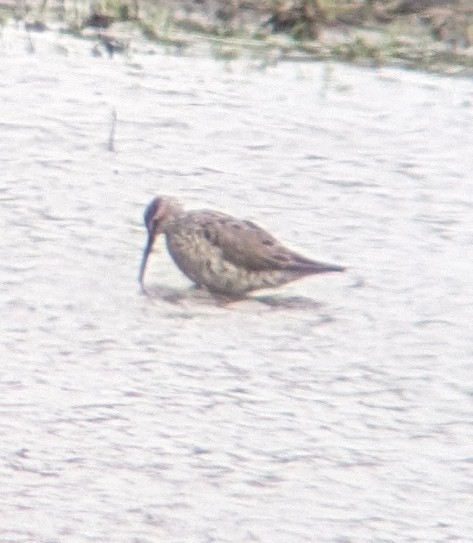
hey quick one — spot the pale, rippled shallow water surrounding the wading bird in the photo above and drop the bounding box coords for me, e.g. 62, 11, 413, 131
0, 27, 473, 543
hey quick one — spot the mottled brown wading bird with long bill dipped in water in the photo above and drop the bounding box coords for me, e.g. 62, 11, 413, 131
138, 196, 345, 298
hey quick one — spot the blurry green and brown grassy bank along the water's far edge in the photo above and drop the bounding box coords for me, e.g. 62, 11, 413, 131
0, 0, 473, 75
